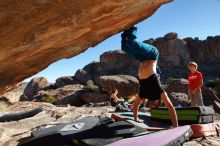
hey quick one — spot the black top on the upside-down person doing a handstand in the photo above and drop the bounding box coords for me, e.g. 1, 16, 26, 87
139, 74, 164, 100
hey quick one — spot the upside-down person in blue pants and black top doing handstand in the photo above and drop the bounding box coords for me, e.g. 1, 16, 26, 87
121, 27, 178, 127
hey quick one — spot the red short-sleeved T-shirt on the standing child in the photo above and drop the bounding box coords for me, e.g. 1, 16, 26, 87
188, 71, 202, 90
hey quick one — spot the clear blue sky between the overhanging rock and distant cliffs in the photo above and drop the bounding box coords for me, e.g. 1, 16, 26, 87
25, 0, 220, 82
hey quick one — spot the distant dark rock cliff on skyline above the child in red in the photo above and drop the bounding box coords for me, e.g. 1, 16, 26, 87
144, 32, 220, 67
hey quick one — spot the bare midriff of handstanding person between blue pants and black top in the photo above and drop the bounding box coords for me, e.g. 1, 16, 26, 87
138, 60, 157, 79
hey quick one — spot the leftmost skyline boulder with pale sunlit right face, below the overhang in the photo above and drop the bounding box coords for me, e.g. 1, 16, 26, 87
23, 77, 50, 101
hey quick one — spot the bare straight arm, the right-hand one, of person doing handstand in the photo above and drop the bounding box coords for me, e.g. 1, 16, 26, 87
161, 92, 179, 127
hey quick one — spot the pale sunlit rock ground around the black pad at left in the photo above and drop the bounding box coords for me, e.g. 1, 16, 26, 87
0, 102, 114, 146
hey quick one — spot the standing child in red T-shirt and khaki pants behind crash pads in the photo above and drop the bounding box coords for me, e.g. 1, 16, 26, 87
188, 62, 204, 106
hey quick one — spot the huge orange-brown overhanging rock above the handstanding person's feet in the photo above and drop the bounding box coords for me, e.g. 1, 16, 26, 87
0, 0, 172, 94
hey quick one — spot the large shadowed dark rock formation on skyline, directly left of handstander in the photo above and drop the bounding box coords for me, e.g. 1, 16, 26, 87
82, 50, 139, 80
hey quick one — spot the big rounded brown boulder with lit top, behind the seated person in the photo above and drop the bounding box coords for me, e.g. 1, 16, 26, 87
96, 75, 139, 98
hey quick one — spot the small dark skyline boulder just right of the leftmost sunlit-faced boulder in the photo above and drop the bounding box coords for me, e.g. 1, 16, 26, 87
55, 76, 79, 88
